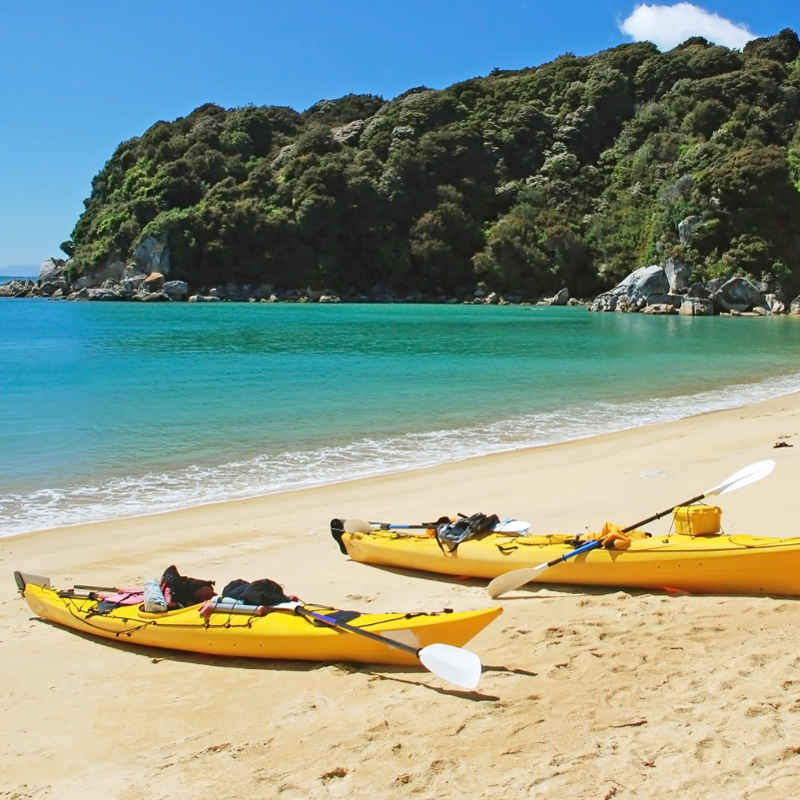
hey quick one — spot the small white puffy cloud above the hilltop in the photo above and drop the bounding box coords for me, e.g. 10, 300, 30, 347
619, 3, 756, 50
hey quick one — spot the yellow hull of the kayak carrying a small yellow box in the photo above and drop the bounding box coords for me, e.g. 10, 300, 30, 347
341, 531, 800, 595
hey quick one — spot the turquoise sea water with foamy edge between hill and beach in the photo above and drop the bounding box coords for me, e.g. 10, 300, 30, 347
0, 299, 800, 535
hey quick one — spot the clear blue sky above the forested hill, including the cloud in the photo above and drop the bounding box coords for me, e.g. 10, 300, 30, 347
0, 0, 800, 274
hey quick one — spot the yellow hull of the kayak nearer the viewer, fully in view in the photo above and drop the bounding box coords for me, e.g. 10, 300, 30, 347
15, 575, 502, 665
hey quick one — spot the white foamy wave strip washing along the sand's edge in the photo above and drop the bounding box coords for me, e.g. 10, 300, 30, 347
0, 373, 800, 537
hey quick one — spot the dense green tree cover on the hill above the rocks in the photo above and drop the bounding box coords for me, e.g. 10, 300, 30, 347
62, 29, 800, 296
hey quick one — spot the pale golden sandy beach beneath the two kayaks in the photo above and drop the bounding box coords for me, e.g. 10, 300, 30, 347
0, 395, 800, 800
